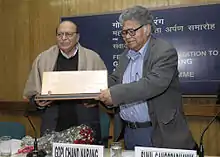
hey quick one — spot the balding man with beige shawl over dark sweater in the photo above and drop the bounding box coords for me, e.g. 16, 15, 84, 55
24, 21, 106, 144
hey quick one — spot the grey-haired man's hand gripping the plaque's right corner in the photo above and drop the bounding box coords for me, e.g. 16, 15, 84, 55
95, 89, 113, 106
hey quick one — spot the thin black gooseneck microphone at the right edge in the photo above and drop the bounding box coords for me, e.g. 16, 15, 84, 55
199, 111, 220, 157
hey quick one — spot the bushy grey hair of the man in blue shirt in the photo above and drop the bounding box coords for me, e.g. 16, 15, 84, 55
119, 6, 156, 32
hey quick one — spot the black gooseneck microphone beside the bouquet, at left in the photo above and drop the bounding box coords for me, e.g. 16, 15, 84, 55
24, 111, 47, 157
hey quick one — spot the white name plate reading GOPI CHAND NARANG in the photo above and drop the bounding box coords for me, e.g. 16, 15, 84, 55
52, 143, 104, 157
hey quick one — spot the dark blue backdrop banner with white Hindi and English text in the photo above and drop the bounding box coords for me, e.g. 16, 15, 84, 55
61, 4, 220, 95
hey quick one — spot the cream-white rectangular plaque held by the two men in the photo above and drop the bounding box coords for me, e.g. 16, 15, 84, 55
35, 70, 108, 100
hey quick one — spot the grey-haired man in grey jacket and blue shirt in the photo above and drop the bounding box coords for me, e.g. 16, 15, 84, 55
97, 6, 196, 149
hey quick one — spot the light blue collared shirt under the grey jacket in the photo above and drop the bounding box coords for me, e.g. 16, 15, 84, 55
120, 39, 150, 122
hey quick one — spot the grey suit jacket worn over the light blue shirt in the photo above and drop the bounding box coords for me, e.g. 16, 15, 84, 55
109, 36, 195, 149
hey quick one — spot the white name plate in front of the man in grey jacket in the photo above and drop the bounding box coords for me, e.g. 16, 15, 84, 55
135, 147, 197, 157
